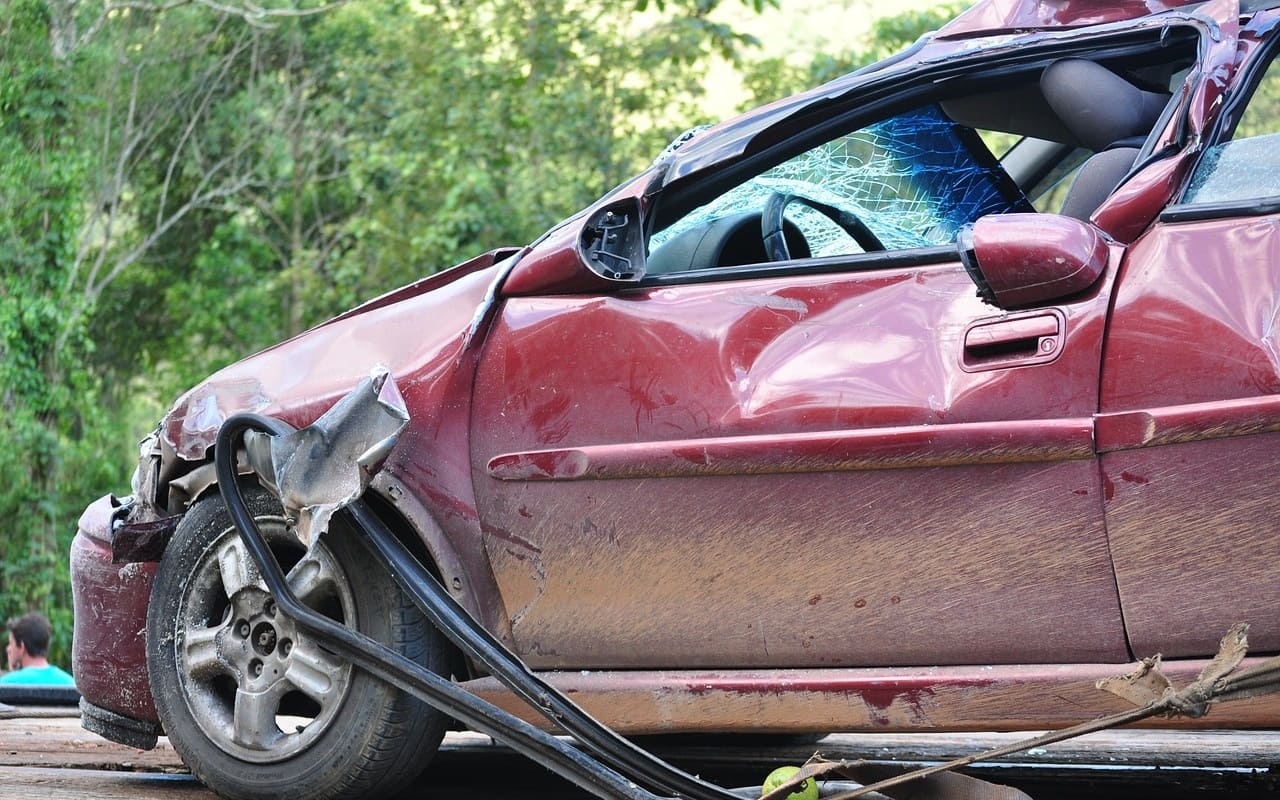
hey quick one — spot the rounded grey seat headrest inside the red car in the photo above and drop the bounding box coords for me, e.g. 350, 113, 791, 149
1041, 59, 1169, 151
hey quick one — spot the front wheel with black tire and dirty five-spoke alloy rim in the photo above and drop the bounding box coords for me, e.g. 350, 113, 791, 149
147, 485, 451, 800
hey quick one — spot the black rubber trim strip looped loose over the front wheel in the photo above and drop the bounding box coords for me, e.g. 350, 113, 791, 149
214, 413, 739, 800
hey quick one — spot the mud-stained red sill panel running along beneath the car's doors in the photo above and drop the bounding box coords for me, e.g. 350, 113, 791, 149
462, 658, 1280, 735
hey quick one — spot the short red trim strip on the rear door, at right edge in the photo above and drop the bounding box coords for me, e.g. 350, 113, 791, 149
1097, 394, 1280, 453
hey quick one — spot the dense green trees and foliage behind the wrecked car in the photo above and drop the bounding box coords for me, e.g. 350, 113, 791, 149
0, 0, 942, 664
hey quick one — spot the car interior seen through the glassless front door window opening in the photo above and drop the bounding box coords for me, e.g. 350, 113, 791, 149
645, 38, 1196, 275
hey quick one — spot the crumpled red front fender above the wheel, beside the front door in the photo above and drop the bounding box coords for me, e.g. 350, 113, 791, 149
156, 259, 504, 630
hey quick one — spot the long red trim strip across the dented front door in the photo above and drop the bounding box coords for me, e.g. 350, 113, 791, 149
488, 417, 1093, 480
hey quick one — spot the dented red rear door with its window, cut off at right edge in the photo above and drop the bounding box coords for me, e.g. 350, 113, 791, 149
1098, 12, 1280, 657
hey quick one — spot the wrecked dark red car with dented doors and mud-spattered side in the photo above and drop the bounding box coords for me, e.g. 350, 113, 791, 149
72, 0, 1280, 796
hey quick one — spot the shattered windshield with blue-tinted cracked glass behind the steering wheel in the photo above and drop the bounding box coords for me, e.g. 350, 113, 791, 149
650, 105, 1030, 257
